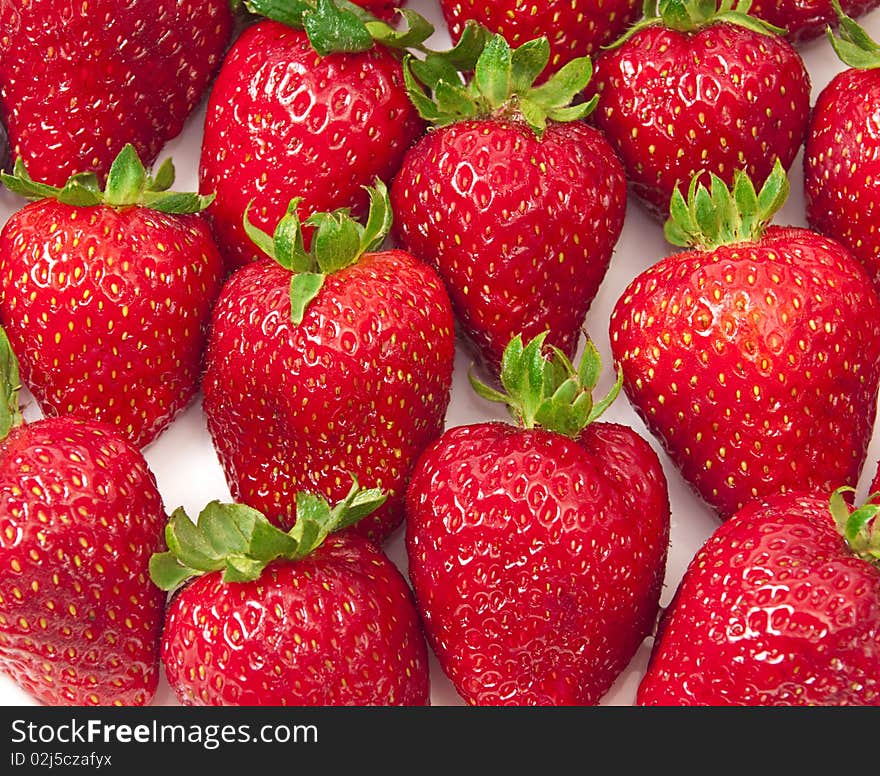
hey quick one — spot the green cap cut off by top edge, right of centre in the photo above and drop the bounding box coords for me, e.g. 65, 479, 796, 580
606, 0, 785, 48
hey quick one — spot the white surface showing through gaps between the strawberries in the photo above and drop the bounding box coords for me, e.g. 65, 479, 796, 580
0, 0, 880, 706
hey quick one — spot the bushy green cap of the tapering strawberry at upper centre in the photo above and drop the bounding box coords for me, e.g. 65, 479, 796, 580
403, 28, 598, 138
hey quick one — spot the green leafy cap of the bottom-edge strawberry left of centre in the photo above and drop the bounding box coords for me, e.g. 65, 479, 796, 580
150, 476, 387, 590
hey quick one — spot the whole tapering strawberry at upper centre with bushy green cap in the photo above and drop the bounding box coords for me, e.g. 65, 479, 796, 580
391, 35, 626, 375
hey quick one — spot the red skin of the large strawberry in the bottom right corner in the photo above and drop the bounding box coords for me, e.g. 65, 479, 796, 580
636, 492, 880, 706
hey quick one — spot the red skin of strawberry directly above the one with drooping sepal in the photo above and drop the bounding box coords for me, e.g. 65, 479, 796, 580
199, 21, 424, 269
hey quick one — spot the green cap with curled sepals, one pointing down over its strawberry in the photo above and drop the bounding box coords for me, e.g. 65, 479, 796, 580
244, 178, 392, 325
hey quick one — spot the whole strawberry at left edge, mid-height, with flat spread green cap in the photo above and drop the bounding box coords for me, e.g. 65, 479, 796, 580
0, 146, 223, 446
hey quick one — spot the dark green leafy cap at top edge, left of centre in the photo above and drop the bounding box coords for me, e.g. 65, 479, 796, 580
244, 0, 434, 57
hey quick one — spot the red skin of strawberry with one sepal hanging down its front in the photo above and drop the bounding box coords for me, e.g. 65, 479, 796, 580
203, 250, 455, 543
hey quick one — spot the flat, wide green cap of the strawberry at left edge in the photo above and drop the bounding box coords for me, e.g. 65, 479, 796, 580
0, 143, 214, 215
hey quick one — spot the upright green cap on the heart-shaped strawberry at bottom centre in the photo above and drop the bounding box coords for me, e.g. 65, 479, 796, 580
469, 331, 623, 438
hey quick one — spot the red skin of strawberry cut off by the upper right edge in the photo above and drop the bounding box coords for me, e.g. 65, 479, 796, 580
804, 68, 880, 289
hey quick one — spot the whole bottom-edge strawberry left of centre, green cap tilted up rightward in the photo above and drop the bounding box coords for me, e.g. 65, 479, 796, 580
150, 482, 429, 706
